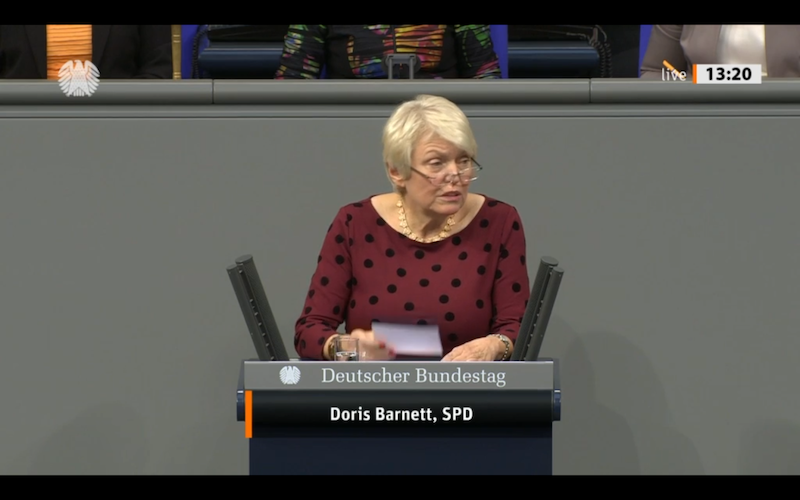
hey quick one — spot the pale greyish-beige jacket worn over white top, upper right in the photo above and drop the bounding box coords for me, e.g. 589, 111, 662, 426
641, 24, 800, 80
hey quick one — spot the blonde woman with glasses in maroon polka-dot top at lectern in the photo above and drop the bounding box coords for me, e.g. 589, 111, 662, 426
294, 96, 530, 361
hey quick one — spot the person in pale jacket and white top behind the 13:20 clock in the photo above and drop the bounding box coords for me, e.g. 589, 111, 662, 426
640, 24, 800, 80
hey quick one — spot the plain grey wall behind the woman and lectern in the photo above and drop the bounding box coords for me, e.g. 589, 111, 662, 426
0, 82, 800, 474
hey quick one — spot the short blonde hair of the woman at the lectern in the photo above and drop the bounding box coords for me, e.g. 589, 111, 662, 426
383, 95, 478, 188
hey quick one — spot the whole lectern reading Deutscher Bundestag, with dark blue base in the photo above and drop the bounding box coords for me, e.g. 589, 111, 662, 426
237, 360, 561, 475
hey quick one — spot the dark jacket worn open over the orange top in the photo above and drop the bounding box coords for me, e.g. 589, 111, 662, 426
0, 24, 172, 80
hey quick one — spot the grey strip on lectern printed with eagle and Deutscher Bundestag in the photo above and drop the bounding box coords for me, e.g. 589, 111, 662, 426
244, 361, 554, 391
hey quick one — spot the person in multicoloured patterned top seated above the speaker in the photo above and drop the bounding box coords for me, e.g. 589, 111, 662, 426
275, 24, 501, 80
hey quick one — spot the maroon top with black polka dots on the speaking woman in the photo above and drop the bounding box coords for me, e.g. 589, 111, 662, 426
294, 196, 530, 359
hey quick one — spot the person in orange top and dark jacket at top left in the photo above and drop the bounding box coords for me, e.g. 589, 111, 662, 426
0, 24, 173, 80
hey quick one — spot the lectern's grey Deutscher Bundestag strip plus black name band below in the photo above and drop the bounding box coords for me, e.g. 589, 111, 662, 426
243, 362, 554, 428
